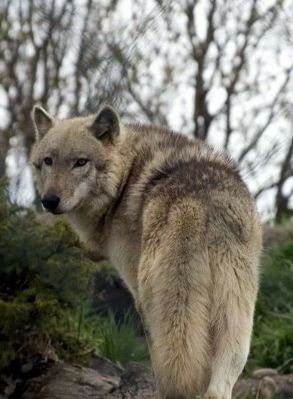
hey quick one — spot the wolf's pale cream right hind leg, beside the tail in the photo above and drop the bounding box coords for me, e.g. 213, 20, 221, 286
205, 247, 257, 399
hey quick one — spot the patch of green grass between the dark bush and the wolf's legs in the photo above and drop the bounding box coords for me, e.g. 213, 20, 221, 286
56, 308, 149, 365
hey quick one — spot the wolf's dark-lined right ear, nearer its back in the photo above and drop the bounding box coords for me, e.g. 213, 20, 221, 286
91, 105, 120, 140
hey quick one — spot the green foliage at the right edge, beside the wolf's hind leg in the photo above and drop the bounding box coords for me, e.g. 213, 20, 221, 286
247, 235, 293, 373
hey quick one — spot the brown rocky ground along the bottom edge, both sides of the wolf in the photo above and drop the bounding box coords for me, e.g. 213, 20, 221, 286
0, 356, 293, 399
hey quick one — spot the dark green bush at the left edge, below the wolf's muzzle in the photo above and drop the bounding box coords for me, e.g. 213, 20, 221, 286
0, 184, 96, 368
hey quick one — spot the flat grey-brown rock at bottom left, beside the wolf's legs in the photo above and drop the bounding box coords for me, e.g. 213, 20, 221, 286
17, 358, 157, 399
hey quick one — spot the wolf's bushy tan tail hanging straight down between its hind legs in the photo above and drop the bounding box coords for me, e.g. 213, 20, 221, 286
143, 205, 211, 399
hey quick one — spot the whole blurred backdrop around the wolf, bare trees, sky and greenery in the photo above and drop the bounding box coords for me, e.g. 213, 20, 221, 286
0, 0, 293, 399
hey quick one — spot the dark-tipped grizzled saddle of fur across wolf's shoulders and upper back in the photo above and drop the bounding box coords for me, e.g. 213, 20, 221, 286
114, 124, 249, 233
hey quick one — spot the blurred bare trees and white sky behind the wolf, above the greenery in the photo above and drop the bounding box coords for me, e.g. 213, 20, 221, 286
0, 0, 293, 221
